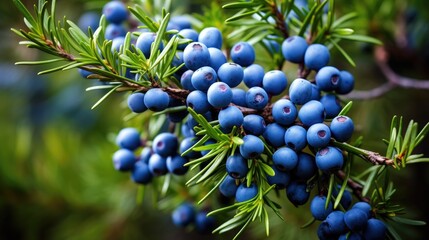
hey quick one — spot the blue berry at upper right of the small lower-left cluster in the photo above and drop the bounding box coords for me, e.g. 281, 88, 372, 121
152, 132, 179, 157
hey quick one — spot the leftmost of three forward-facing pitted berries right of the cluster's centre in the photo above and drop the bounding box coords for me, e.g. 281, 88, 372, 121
272, 99, 298, 126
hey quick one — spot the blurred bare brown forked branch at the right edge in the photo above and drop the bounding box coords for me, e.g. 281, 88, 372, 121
343, 47, 429, 100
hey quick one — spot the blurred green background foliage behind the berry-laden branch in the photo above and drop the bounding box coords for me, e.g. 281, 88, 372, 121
0, 0, 429, 240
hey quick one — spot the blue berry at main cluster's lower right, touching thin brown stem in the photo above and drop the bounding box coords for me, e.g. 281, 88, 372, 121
316, 146, 344, 171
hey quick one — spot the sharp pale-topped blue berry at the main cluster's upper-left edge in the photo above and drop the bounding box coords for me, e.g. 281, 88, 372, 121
183, 42, 210, 71
